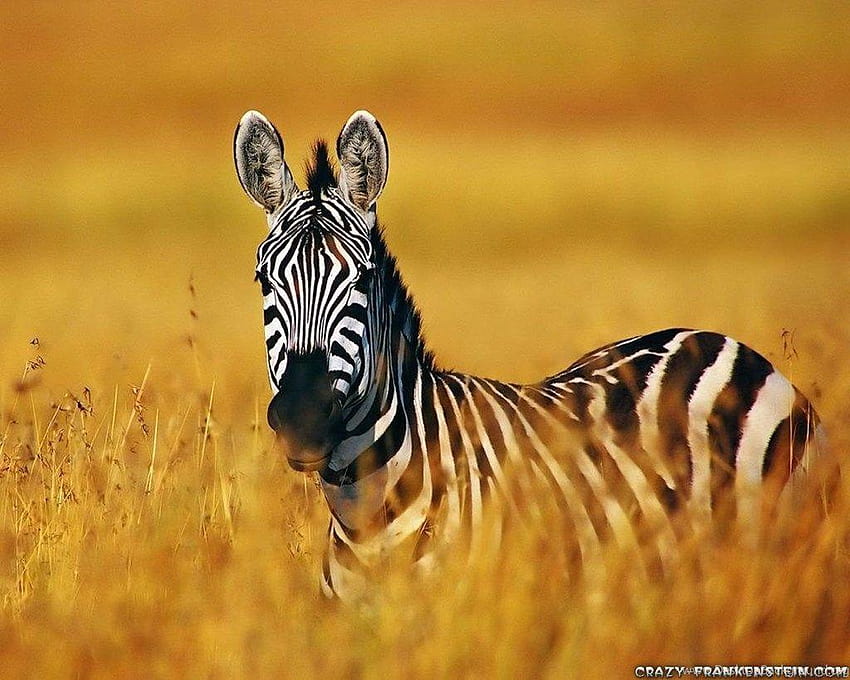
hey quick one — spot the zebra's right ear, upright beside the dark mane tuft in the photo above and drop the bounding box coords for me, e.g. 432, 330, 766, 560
336, 111, 390, 212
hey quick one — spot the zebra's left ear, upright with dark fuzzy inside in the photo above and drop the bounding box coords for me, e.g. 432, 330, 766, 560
233, 111, 298, 213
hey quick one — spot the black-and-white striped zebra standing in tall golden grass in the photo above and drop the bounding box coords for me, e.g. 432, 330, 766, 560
234, 111, 821, 600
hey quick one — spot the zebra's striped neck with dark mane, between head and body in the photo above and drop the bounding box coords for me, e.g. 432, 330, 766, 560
320, 237, 484, 548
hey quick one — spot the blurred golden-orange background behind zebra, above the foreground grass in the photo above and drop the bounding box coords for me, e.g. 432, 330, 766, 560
0, 0, 850, 404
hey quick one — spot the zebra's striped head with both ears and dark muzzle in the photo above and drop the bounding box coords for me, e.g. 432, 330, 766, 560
234, 111, 389, 471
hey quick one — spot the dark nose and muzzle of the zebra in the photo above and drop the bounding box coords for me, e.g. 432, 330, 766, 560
268, 351, 342, 471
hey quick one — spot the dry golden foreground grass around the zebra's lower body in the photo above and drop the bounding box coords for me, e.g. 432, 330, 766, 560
0, 354, 850, 678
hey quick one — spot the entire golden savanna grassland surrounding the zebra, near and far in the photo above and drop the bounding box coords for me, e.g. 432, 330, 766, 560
0, 0, 850, 678
